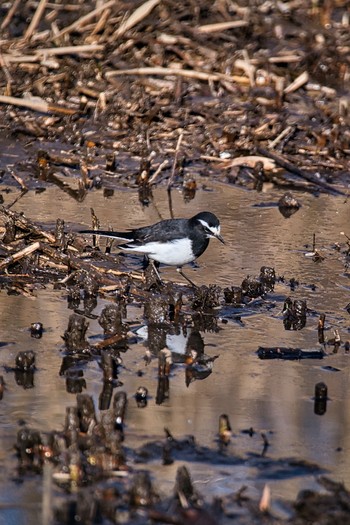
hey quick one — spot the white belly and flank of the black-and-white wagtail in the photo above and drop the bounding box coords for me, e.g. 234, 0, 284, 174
121, 239, 195, 266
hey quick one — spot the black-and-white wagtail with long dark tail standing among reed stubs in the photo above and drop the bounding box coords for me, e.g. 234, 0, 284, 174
79, 211, 224, 286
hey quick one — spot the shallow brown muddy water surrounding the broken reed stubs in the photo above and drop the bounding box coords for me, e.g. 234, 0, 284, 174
0, 183, 350, 525
